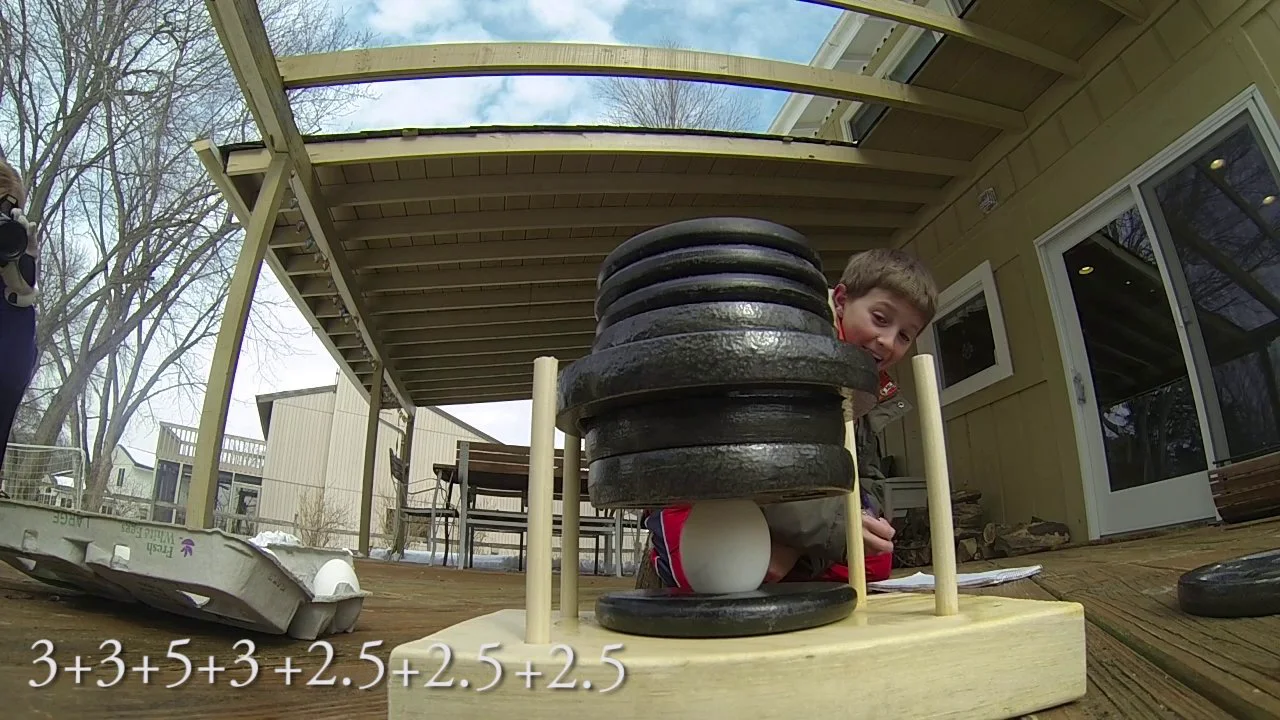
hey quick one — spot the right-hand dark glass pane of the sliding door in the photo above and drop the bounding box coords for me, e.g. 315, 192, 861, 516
1148, 117, 1280, 460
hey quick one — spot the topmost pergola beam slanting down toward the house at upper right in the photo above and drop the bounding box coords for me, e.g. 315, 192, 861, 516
804, 0, 1083, 78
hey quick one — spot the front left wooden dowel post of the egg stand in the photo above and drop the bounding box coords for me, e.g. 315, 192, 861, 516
525, 356, 559, 644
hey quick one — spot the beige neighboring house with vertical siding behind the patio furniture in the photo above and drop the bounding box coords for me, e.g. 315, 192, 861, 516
257, 375, 499, 547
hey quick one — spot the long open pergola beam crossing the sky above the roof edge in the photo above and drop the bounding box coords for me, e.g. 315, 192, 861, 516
276, 42, 1027, 131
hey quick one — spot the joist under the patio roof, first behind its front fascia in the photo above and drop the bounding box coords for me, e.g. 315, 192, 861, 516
324, 173, 941, 208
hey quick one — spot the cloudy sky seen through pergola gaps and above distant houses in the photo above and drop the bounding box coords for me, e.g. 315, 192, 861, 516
125, 0, 840, 457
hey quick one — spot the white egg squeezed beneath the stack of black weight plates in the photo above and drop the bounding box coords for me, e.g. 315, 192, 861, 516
680, 500, 772, 593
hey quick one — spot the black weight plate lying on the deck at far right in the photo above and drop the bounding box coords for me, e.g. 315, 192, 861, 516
1178, 548, 1280, 618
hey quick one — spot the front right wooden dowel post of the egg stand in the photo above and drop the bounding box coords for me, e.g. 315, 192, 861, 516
911, 355, 960, 615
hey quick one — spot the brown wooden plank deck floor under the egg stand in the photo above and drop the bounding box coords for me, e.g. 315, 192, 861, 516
0, 520, 1280, 720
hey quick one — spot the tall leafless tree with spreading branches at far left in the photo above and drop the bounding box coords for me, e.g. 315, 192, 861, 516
0, 0, 364, 507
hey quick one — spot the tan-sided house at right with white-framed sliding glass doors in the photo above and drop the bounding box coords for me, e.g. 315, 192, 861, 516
771, 0, 1280, 541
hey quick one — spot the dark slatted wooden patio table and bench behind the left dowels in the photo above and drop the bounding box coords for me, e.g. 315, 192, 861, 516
434, 441, 622, 574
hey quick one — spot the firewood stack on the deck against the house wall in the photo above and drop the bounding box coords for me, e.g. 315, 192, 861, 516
893, 489, 1071, 568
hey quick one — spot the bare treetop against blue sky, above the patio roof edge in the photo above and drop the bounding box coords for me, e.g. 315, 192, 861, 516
594, 40, 758, 131
